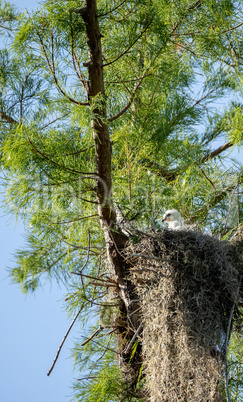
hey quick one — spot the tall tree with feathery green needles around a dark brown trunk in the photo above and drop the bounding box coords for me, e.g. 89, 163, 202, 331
0, 0, 243, 401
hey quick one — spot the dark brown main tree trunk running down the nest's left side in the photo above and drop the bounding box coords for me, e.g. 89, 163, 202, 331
79, 0, 142, 388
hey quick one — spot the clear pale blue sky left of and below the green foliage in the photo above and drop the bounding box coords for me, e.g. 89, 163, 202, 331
0, 0, 80, 402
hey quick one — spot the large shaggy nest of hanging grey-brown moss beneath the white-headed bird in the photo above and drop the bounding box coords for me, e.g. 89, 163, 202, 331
126, 230, 243, 402
